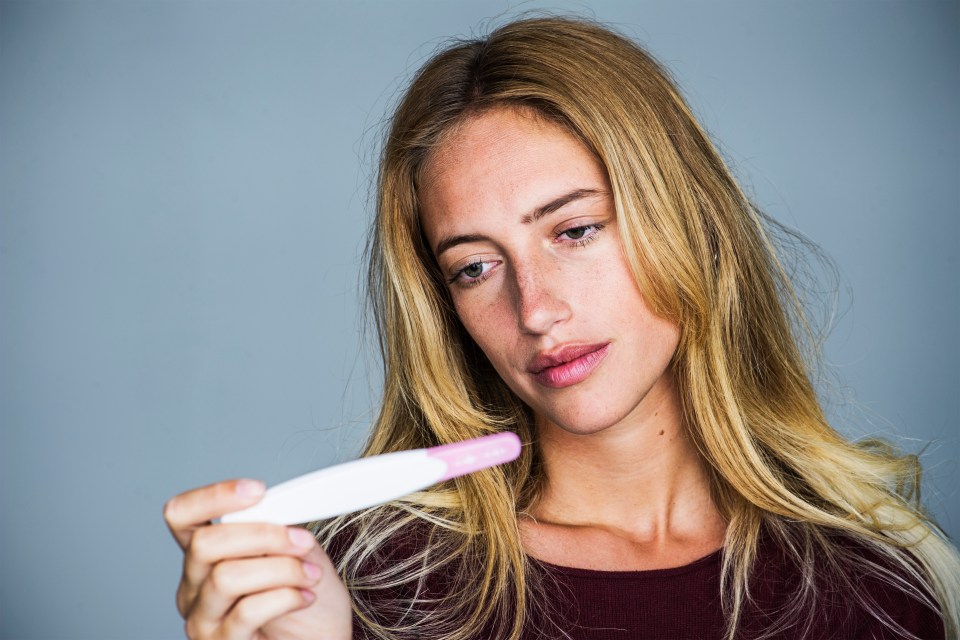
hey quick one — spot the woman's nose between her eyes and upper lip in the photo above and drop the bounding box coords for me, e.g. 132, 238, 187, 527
514, 262, 570, 335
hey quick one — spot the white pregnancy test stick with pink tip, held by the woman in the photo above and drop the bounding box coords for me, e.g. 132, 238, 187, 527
220, 432, 520, 524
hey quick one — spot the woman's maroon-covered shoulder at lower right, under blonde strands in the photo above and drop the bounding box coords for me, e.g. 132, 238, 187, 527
747, 534, 945, 640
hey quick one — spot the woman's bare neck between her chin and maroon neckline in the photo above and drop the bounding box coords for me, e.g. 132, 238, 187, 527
531, 380, 724, 548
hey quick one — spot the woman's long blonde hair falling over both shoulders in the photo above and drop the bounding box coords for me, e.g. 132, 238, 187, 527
318, 17, 960, 640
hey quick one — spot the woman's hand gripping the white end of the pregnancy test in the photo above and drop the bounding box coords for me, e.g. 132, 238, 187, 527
163, 480, 351, 640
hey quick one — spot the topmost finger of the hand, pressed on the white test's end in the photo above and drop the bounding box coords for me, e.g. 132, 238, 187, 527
163, 479, 265, 549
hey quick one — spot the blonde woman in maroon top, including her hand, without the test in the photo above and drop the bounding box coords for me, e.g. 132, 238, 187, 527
165, 18, 960, 639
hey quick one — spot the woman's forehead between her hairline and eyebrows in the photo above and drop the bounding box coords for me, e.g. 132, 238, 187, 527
418, 107, 607, 236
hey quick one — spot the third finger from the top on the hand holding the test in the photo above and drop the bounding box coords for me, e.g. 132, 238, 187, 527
193, 556, 322, 620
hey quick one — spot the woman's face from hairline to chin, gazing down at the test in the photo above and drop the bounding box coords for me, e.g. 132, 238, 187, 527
420, 108, 679, 433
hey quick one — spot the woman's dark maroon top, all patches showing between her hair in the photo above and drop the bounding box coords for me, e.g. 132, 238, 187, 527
329, 536, 945, 640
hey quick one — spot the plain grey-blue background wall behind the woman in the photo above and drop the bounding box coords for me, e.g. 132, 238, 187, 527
0, 1, 960, 639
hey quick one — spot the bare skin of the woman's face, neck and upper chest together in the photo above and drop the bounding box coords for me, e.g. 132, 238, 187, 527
420, 108, 725, 570
